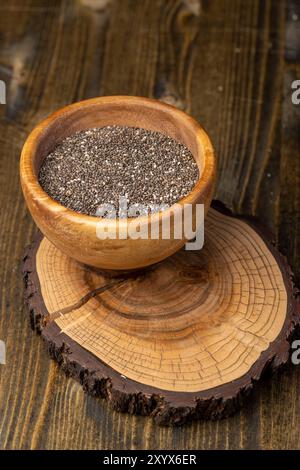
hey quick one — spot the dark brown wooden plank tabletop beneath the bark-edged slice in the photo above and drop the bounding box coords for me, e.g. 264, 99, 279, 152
0, 0, 300, 449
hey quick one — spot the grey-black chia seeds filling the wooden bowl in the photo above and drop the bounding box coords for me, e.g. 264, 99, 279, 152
39, 126, 199, 217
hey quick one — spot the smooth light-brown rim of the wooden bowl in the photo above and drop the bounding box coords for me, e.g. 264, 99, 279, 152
20, 95, 216, 229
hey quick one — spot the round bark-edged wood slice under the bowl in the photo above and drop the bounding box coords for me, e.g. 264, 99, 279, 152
23, 205, 299, 425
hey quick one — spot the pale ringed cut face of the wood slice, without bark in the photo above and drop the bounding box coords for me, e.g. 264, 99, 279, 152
32, 210, 287, 392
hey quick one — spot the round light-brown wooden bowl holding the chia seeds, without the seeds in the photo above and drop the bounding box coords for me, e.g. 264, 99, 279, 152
20, 96, 215, 270
